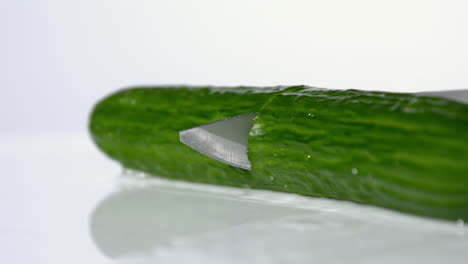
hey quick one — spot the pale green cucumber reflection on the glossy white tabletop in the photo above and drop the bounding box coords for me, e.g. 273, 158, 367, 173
91, 175, 468, 263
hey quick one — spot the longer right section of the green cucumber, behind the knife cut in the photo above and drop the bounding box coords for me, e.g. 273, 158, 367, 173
249, 87, 468, 219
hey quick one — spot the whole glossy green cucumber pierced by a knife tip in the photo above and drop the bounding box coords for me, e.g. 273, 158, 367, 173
90, 87, 468, 219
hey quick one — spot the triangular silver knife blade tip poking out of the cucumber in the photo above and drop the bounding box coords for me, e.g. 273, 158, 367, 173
179, 112, 258, 170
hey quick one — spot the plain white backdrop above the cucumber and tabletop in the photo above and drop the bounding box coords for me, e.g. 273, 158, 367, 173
0, 0, 468, 133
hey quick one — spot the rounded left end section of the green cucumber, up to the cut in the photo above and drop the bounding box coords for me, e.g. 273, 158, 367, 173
89, 87, 283, 186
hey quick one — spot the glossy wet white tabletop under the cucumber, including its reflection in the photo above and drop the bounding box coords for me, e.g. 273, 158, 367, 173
0, 135, 468, 263
